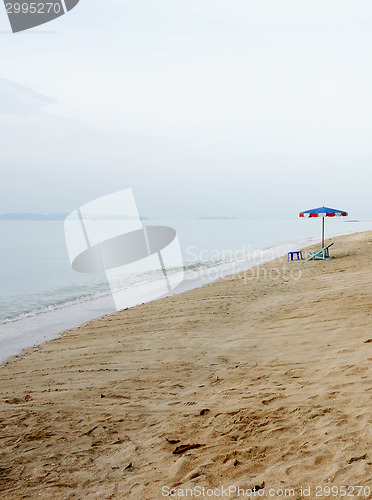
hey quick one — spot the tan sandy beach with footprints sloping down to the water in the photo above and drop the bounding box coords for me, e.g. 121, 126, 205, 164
0, 233, 372, 500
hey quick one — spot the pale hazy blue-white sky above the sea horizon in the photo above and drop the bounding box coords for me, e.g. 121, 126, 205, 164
0, 0, 372, 218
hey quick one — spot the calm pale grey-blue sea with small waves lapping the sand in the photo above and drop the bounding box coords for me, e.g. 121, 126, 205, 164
0, 218, 372, 361
